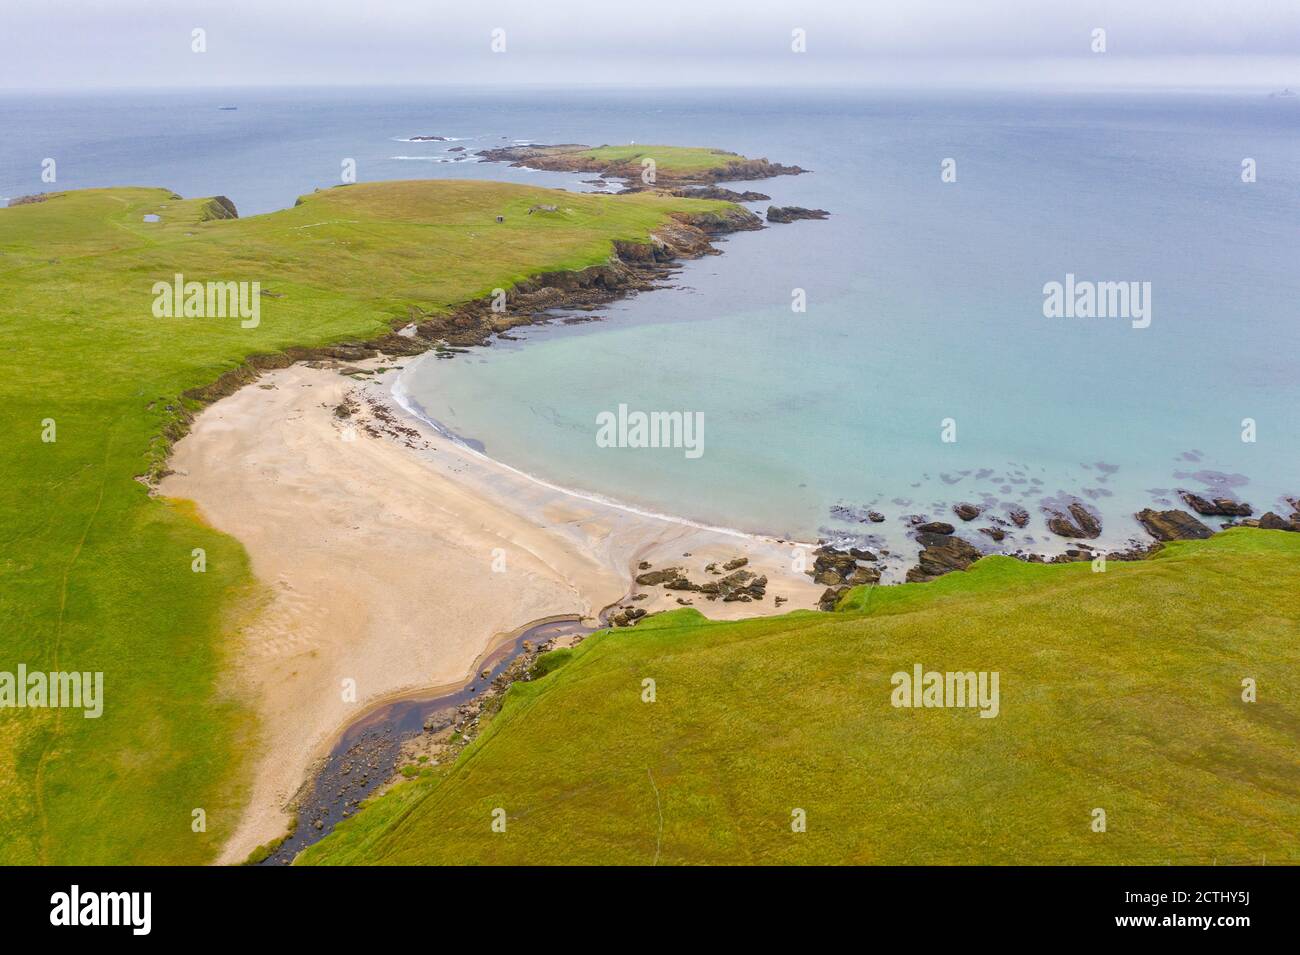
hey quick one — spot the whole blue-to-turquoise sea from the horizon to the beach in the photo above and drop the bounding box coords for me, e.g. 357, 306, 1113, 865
0, 88, 1300, 551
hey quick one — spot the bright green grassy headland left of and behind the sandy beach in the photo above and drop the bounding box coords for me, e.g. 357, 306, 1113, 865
0, 182, 738, 863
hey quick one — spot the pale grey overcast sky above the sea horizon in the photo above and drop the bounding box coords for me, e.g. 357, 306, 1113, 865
0, 0, 1300, 90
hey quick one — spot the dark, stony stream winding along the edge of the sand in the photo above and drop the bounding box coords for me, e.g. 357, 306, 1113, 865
257, 620, 599, 865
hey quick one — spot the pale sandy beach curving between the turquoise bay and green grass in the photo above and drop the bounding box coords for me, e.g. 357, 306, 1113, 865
159, 360, 823, 864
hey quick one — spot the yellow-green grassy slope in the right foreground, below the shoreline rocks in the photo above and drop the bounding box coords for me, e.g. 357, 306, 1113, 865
302, 530, 1300, 864
